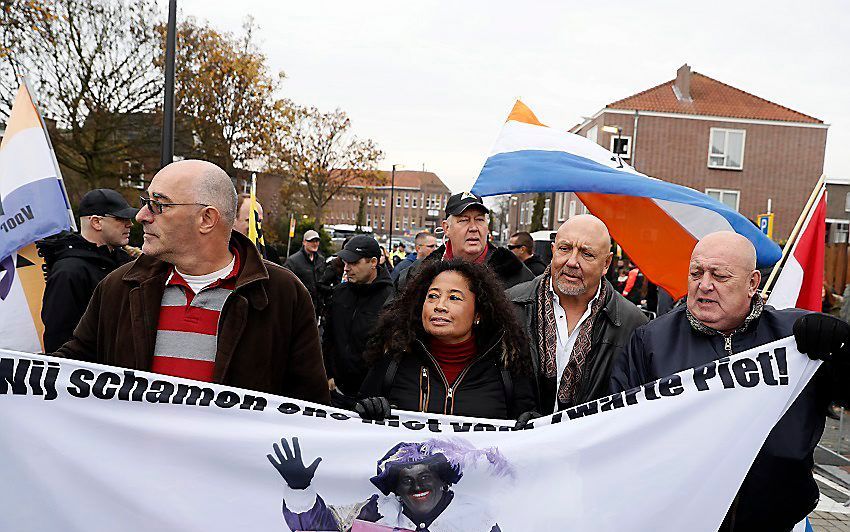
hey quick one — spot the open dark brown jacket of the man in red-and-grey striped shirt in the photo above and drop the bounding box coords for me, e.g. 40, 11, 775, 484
53, 232, 330, 404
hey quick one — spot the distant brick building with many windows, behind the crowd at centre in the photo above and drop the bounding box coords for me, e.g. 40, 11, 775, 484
324, 170, 451, 237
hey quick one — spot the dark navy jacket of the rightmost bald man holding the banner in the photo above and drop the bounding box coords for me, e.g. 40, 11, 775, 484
610, 305, 848, 531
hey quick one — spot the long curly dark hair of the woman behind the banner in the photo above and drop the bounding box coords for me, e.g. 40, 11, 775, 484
364, 259, 531, 375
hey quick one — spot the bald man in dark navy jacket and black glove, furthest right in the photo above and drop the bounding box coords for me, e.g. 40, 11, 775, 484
610, 232, 850, 531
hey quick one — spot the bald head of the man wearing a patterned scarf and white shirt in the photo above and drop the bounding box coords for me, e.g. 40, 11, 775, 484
552, 214, 612, 299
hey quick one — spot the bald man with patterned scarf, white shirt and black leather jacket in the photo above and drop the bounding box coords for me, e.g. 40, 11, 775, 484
508, 214, 647, 416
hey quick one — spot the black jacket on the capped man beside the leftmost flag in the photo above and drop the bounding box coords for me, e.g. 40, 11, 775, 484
36, 232, 132, 353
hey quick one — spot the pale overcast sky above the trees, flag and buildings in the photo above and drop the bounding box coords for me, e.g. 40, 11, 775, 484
158, 0, 850, 191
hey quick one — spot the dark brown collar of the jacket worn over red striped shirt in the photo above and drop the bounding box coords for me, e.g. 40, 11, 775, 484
122, 231, 269, 309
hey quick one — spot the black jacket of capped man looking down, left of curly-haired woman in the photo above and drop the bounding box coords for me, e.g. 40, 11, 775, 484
322, 267, 393, 397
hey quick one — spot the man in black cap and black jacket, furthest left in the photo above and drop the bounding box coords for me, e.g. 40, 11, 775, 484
37, 188, 138, 353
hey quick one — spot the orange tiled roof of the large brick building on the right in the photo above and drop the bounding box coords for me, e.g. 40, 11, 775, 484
606, 72, 823, 124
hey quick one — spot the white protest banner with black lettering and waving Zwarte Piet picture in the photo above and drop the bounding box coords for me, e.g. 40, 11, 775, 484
0, 338, 818, 532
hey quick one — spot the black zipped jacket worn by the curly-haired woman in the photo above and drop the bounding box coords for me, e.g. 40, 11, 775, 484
360, 335, 537, 419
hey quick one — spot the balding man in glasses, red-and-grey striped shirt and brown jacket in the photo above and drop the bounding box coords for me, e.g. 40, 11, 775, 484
56, 160, 330, 404
